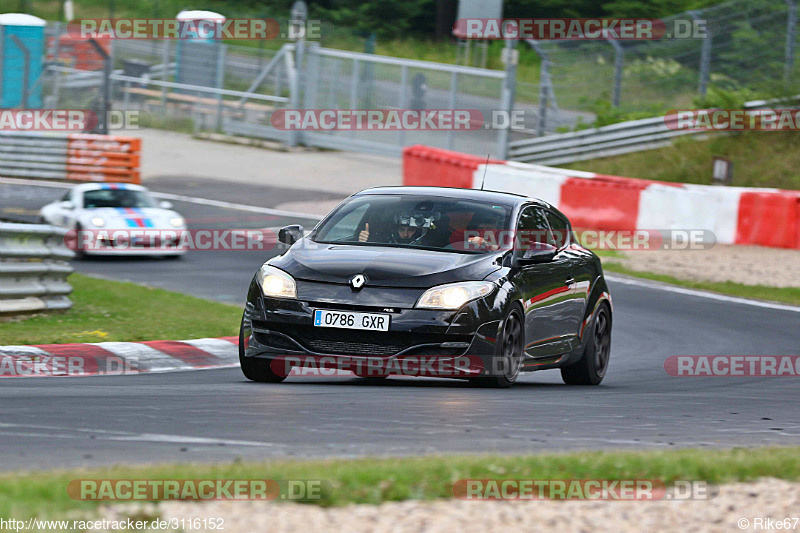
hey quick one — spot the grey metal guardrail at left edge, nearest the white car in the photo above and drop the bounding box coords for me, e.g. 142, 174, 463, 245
0, 222, 75, 315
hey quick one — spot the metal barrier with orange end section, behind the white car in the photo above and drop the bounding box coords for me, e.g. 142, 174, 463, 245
0, 131, 141, 183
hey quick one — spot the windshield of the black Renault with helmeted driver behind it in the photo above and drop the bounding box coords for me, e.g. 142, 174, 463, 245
312, 194, 511, 253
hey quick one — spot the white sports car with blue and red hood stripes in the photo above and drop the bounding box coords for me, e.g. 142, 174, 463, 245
40, 183, 186, 258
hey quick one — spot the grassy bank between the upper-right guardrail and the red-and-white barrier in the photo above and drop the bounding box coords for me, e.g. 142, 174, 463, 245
566, 131, 800, 189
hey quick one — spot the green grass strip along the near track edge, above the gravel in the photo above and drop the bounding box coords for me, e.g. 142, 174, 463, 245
0, 448, 800, 519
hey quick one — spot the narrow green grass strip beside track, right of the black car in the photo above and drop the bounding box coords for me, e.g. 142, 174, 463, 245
598, 260, 800, 306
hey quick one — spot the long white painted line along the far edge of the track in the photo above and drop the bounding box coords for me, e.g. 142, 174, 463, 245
6, 178, 800, 313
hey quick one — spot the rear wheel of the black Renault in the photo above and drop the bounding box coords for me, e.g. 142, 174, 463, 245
561, 304, 611, 385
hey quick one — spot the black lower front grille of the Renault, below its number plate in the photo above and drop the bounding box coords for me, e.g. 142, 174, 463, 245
253, 320, 470, 355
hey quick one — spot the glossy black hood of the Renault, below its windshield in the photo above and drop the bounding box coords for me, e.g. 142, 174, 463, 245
269, 239, 500, 288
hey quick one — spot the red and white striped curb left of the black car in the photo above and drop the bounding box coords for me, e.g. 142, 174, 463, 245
0, 337, 239, 378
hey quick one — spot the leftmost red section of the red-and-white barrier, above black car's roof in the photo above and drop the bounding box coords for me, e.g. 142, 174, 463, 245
403, 145, 505, 189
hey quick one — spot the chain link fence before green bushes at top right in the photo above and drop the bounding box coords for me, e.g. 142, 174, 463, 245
535, 0, 800, 131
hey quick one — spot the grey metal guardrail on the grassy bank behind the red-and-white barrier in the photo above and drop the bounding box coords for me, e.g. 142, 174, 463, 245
509, 97, 798, 165
